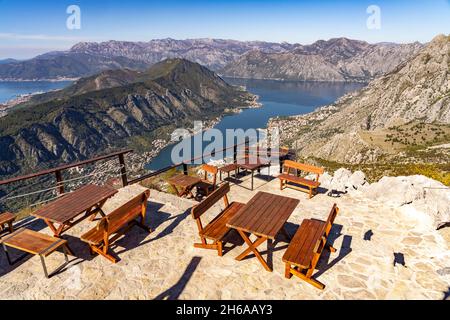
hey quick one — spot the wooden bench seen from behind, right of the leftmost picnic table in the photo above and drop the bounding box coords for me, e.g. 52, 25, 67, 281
81, 190, 151, 263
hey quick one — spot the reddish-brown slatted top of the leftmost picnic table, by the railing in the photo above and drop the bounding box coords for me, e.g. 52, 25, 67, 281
31, 184, 117, 224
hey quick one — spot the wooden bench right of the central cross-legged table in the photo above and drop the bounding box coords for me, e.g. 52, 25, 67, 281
283, 204, 339, 290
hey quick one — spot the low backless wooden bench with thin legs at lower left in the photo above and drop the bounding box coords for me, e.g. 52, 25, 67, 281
1, 228, 69, 278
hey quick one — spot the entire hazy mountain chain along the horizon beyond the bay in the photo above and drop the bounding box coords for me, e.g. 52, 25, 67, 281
0, 38, 422, 81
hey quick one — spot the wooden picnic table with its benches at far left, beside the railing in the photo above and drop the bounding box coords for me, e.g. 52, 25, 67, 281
0, 184, 150, 278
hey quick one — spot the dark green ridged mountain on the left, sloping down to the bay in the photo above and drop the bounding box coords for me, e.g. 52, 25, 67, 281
0, 59, 254, 175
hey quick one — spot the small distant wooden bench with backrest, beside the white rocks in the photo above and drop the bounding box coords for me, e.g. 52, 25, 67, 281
278, 160, 324, 199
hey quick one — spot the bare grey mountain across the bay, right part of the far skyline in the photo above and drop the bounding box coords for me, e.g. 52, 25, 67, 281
220, 38, 422, 81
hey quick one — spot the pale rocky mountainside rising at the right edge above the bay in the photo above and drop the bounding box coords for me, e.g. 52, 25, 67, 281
270, 35, 450, 163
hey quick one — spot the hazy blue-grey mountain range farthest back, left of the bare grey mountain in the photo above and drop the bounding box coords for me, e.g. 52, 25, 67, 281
0, 39, 293, 80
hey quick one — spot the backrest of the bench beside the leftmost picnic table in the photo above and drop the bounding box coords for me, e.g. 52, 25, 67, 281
97, 190, 150, 234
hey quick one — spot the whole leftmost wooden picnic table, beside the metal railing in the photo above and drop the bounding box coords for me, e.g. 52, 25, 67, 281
31, 184, 117, 251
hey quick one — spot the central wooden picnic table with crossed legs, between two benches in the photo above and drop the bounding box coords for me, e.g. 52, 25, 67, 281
227, 191, 299, 271
